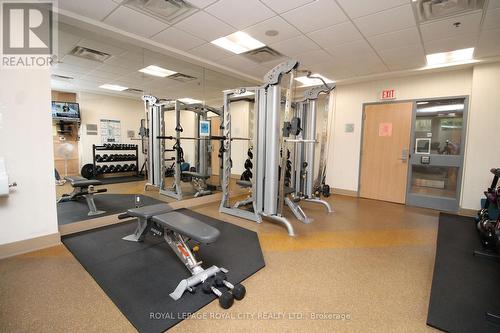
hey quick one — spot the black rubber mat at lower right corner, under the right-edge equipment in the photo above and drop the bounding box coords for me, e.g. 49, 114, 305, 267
427, 213, 500, 332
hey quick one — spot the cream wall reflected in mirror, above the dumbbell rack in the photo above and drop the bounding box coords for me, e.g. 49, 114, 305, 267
77, 92, 144, 168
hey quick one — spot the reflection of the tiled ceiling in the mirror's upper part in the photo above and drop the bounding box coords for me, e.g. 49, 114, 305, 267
51, 23, 252, 105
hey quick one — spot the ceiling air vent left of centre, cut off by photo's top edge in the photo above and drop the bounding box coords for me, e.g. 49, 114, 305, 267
124, 0, 198, 24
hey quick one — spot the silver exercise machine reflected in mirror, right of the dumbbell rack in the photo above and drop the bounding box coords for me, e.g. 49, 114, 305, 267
141, 95, 221, 200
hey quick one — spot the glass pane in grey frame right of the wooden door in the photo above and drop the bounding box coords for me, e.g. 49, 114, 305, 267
406, 97, 468, 212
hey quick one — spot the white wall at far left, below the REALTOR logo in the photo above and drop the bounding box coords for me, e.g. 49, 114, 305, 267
0, 69, 57, 244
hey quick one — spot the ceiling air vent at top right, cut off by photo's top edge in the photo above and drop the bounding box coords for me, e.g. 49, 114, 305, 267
412, 0, 484, 23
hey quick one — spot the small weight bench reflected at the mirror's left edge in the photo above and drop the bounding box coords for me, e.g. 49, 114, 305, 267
57, 176, 108, 216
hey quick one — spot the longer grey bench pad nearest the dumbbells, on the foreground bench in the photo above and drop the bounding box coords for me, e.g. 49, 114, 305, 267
153, 211, 220, 244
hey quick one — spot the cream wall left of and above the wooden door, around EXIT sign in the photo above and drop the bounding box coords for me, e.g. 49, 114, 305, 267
326, 68, 472, 191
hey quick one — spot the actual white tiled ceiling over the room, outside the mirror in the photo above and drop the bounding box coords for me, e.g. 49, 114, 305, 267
54, 0, 500, 91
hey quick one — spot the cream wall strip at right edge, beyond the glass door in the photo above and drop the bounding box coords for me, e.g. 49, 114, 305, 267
461, 63, 500, 209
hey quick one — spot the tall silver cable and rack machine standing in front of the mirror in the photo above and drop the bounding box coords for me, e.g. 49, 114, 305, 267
219, 60, 333, 236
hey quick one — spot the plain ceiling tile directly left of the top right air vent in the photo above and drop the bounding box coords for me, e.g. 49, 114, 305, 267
354, 4, 416, 36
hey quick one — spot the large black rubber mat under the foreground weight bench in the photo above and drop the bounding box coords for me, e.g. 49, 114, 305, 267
62, 209, 265, 332
